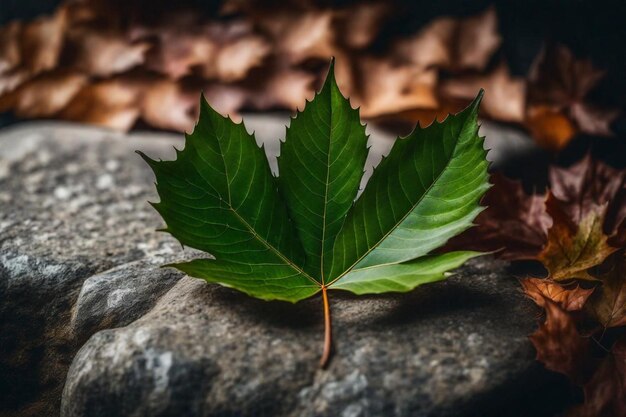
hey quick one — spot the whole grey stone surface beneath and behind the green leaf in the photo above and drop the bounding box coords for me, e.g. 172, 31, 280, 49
0, 116, 548, 416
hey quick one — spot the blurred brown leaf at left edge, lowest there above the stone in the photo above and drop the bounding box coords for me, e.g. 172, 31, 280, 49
0, 71, 87, 118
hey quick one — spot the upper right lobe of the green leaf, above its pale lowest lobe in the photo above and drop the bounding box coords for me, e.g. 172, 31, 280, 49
328, 91, 489, 282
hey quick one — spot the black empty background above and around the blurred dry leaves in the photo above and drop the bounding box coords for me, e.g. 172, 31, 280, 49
0, 0, 626, 179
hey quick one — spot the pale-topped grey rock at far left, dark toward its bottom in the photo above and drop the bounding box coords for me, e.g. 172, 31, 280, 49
0, 123, 180, 416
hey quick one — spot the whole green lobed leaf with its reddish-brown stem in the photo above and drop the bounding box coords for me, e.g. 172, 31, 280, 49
142, 61, 488, 363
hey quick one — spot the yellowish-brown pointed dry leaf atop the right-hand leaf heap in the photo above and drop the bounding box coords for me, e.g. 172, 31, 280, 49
537, 193, 617, 281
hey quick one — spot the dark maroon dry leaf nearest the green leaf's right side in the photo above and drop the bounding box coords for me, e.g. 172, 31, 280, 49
446, 174, 552, 260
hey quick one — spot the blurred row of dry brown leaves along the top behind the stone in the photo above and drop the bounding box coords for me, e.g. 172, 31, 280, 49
0, 0, 618, 149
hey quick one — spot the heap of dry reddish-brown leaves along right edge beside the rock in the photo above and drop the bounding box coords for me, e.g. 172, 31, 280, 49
450, 156, 626, 417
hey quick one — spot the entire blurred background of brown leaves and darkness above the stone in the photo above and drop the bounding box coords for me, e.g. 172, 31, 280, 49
0, 0, 626, 185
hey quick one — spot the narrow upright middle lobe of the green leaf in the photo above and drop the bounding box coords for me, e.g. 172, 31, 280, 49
278, 64, 367, 282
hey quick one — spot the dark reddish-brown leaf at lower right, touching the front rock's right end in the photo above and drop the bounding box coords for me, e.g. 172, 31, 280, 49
529, 299, 590, 384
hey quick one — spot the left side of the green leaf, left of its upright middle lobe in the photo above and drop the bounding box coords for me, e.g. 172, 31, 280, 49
140, 99, 319, 301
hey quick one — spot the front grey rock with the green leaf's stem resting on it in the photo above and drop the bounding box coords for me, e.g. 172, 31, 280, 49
61, 259, 541, 417
